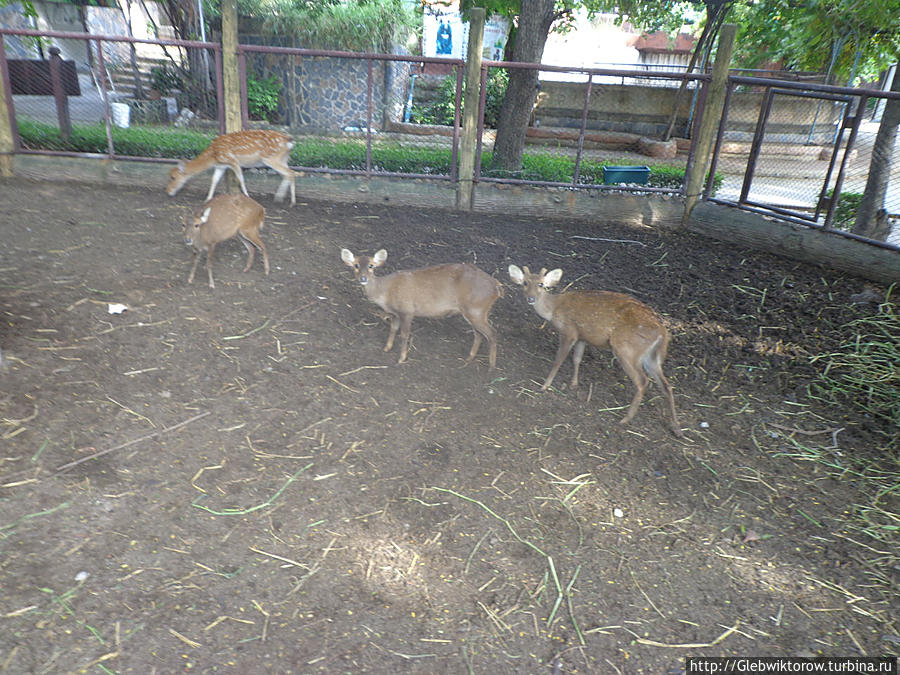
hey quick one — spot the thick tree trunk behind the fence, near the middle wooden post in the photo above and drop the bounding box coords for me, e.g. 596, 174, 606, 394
491, 0, 558, 171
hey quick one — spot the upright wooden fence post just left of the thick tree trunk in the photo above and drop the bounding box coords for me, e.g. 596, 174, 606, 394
456, 7, 485, 211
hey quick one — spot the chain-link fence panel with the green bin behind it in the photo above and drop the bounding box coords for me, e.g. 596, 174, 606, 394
476, 62, 709, 193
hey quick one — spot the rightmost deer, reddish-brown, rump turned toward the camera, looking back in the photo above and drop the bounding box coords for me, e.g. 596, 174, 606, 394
509, 265, 684, 438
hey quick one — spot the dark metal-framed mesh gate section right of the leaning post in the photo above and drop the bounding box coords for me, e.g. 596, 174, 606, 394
705, 77, 867, 229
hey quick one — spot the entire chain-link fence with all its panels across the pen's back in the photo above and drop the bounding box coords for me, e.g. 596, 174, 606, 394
0, 29, 900, 248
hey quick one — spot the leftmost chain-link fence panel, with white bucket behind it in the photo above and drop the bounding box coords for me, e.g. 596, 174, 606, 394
0, 32, 222, 159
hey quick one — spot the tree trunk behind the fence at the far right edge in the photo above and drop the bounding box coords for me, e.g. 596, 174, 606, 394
853, 64, 900, 241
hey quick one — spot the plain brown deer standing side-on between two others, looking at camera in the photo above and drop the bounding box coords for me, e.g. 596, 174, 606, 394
341, 248, 503, 370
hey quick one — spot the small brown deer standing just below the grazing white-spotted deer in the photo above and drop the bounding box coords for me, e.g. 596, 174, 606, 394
184, 194, 269, 288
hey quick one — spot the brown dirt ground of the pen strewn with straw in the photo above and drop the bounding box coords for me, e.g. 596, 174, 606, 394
0, 178, 900, 675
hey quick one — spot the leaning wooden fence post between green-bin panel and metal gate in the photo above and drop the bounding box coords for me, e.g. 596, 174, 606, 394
681, 23, 737, 225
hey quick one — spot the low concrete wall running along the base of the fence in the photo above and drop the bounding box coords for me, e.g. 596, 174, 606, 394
8, 155, 900, 284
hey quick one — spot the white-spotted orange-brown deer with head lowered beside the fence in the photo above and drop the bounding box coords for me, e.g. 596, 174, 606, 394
166, 129, 297, 206
